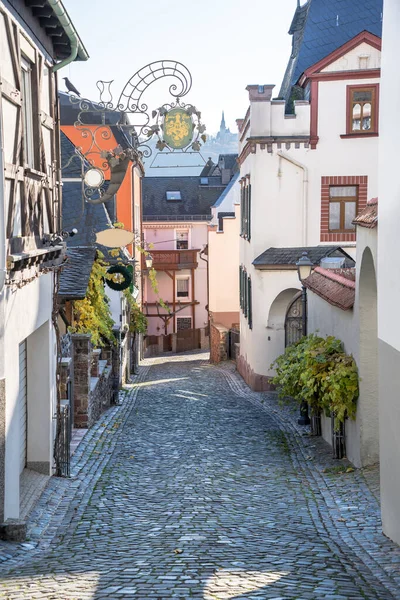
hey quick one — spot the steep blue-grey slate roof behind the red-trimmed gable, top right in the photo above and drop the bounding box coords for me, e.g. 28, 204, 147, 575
279, 0, 383, 101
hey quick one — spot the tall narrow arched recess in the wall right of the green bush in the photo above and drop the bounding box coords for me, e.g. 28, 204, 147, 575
357, 247, 379, 466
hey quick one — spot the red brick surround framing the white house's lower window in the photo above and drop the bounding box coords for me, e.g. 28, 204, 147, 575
321, 175, 368, 242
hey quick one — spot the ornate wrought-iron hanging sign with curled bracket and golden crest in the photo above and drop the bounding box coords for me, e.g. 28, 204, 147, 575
65, 60, 206, 204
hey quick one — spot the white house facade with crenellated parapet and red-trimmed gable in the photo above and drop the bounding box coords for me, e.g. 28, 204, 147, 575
238, 31, 380, 390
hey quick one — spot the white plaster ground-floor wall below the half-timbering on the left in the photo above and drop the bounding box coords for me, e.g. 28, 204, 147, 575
4, 274, 56, 519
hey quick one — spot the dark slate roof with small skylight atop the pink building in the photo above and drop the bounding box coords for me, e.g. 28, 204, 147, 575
142, 176, 225, 221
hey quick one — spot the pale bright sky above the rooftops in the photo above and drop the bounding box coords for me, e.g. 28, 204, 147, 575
60, 0, 297, 134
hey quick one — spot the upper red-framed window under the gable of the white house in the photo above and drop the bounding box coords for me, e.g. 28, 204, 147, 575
347, 85, 378, 135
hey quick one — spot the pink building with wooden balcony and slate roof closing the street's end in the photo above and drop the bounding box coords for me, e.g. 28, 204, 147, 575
143, 155, 237, 349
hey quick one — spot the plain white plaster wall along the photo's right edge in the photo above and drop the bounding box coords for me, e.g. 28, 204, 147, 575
378, 0, 400, 544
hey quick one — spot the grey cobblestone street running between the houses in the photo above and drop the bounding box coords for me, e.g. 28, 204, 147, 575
0, 354, 400, 600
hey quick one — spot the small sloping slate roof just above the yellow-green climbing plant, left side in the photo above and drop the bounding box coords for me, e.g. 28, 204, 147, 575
59, 246, 96, 300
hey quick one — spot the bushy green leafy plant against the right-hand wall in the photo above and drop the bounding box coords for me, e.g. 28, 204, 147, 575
271, 334, 359, 428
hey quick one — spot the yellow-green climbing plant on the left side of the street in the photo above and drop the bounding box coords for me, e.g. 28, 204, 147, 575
70, 252, 115, 346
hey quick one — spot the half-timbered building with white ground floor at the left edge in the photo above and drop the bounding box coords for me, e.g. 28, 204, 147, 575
0, 0, 88, 521
